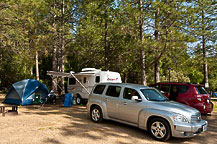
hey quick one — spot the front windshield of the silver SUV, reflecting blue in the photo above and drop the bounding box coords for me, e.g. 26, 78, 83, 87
140, 89, 168, 101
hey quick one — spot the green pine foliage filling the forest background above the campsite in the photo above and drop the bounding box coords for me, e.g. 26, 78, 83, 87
0, 0, 217, 89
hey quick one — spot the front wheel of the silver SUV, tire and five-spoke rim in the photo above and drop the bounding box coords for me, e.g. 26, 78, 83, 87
148, 118, 171, 141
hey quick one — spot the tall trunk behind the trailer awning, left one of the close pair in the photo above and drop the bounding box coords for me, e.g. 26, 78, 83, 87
52, 0, 57, 93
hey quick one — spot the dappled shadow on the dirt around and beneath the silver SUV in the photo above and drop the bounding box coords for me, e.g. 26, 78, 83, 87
1, 95, 217, 144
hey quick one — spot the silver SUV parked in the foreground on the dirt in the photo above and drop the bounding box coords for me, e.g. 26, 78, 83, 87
87, 83, 207, 141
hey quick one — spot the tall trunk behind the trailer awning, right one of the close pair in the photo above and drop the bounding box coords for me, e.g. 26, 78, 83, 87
60, 0, 65, 94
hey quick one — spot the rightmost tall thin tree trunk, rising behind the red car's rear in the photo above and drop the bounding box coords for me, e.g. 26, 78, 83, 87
202, 10, 209, 89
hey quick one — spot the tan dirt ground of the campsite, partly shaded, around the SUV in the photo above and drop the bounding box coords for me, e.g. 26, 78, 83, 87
0, 95, 217, 144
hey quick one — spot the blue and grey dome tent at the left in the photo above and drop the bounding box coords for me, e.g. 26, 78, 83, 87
4, 79, 49, 105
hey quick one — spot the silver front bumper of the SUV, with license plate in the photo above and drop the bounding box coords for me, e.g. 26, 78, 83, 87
171, 120, 208, 138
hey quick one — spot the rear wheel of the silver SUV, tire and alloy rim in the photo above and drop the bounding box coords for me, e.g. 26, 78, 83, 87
90, 106, 103, 123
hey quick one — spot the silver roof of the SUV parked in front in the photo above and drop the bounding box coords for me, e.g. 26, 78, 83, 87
98, 83, 151, 89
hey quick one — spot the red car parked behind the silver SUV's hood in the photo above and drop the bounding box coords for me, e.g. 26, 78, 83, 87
151, 82, 213, 114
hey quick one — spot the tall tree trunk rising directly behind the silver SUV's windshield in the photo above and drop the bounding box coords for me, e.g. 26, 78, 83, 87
139, 0, 147, 85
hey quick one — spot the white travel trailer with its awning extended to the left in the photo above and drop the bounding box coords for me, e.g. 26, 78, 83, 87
47, 68, 122, 104
